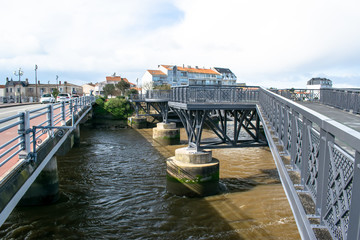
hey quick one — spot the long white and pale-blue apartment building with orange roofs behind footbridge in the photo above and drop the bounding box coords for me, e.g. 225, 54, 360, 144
141, 65, 236, 88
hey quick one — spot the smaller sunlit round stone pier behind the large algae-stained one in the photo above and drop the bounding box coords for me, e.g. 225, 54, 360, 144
153, 123, 180, 145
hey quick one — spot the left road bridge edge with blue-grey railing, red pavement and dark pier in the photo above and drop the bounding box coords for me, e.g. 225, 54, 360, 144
0, 96, 95, 225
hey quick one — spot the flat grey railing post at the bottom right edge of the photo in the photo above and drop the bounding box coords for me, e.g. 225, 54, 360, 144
346, 151, 360, 240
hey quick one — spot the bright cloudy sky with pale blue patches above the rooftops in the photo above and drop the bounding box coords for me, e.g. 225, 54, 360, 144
0, 0, 360, 88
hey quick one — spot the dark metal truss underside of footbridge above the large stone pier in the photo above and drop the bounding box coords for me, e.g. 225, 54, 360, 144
171, 105, 267, 150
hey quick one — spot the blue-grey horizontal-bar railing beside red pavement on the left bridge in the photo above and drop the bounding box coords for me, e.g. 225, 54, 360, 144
0, 96, 95, 176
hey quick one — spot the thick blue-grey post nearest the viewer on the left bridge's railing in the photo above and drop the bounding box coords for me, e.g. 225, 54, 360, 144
19, 111, 30, 159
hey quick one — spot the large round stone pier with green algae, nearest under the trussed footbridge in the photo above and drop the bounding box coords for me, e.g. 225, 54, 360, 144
166, 148, 219, 197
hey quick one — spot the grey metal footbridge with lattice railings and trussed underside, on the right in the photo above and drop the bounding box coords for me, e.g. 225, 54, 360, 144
133, 86, 360, 239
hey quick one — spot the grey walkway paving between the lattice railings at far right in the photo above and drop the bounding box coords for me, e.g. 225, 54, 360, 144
297, 102, 360, 132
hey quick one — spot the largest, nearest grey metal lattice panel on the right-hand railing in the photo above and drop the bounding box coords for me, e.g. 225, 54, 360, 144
324, 143, 354, 239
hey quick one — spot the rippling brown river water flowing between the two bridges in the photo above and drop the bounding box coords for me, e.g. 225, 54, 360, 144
0, 128, 300, 240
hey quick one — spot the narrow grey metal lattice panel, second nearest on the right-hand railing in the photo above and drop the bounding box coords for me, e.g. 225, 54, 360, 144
305, 128, 320, 200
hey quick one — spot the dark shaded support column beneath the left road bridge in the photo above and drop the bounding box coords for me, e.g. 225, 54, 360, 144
19, 156, 59, 206
